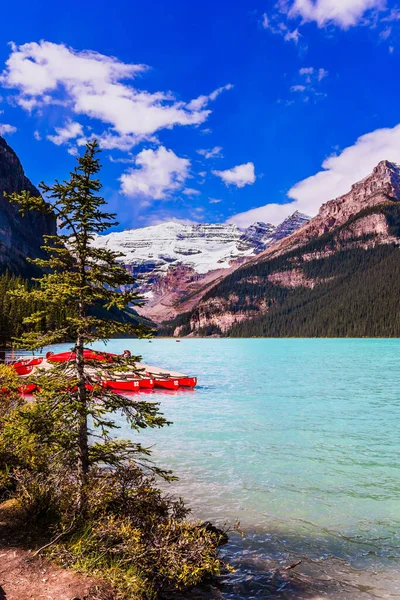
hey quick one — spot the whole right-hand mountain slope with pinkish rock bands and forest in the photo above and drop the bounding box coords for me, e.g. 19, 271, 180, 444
164, 161, 400, 337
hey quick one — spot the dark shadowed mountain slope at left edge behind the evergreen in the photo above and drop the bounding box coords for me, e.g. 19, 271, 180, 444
0, 137, 56, 274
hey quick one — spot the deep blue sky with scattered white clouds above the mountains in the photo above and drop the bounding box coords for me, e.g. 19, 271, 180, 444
0, 0, 400, 228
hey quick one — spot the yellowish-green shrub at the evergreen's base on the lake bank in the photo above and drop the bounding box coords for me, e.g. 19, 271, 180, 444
19, 464, 225, 600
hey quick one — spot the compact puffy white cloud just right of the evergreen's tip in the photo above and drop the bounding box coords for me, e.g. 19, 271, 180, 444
120, 146, 190, 200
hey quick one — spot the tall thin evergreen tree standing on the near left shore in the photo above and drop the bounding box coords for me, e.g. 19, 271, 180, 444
9, 141, 166, 509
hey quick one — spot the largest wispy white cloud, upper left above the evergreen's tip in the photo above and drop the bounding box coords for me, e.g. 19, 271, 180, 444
0, 41, 232, 149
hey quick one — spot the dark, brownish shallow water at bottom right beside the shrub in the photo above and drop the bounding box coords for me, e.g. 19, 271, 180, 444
179, 530, 400, 600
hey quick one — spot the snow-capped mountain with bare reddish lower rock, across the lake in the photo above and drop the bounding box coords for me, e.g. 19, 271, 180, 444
94, 213, 308, 322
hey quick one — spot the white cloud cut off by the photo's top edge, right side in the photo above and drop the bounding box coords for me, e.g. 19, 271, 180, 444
279, 0, 386, 29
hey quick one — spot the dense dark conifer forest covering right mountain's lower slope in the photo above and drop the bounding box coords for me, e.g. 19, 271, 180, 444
228, 246, 400, 337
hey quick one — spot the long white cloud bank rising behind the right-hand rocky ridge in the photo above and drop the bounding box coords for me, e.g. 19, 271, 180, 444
230, 124, 400, 227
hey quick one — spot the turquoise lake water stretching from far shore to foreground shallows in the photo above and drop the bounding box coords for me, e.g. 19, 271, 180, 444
39, 339, 400, 599
